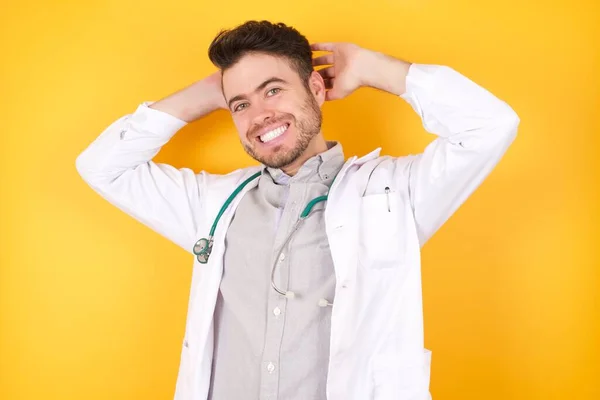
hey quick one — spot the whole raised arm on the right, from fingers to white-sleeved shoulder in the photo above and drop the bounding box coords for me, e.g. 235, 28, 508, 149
313, 43, 520, 246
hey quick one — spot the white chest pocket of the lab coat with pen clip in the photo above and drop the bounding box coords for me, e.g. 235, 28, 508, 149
358, 192, 405, 269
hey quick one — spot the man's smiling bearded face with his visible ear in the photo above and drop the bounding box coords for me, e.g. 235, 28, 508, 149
223, 54, 326, 172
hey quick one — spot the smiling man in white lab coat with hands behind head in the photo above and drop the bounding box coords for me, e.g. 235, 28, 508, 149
77, 21, 519, 400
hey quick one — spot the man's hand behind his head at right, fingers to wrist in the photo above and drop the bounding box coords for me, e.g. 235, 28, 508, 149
310, 43, 367, 100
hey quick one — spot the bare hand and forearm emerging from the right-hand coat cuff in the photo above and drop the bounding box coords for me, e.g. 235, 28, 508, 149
311, 43, 411, 100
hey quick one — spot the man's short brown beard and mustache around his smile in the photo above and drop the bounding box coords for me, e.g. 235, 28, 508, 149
242, 94, 322, 168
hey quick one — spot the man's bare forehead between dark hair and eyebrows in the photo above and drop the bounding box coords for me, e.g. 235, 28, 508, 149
223, 53, 300, 99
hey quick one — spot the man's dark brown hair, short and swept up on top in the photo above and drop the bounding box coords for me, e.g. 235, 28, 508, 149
208, 21, 313, 85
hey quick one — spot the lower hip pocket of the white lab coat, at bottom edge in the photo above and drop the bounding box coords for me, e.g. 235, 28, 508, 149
373, 349, 431, 400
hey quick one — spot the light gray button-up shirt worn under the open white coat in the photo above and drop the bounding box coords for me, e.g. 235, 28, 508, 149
208, 142, 344, 400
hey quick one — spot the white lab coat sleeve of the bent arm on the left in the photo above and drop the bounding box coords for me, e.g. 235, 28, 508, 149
76, 102, 211, 252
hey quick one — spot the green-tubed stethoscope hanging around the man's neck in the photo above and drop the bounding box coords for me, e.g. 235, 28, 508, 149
192, 172, 335, 307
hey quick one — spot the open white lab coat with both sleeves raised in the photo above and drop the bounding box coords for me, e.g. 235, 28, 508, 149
76, 64, 519, 400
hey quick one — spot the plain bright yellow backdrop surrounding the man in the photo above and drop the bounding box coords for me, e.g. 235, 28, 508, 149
0, 0, 600, 400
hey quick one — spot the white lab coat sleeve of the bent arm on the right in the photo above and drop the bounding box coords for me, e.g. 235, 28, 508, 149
401, 64, 520, 246
